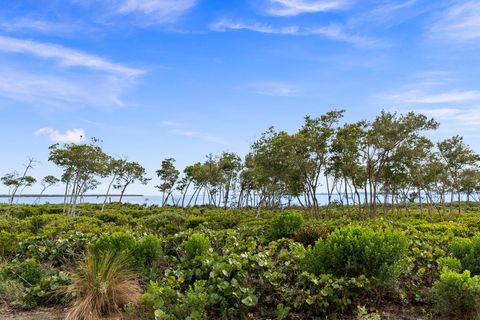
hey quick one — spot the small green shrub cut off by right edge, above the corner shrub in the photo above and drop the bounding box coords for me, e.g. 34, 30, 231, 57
449, 236, 480, 275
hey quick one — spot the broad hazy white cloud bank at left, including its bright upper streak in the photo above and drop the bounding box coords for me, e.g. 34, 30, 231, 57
0, 36, 144, 110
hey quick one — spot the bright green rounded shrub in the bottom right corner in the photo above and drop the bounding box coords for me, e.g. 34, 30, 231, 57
432, 269, 480, 319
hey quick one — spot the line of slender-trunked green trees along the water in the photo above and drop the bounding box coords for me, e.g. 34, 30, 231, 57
1, 110, 480, 217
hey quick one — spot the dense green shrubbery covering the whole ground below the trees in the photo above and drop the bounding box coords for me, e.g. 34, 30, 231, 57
0, 204, 480, 320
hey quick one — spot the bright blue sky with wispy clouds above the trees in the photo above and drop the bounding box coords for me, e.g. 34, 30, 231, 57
0, 0, 480, 194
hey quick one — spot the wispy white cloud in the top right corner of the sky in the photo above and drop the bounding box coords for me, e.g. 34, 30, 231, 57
430, 0, 480, 41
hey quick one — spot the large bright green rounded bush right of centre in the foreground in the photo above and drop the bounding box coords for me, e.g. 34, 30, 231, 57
305, 226, 408, 282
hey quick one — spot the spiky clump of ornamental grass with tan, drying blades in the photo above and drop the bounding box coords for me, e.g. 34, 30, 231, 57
66, 251, 141, 320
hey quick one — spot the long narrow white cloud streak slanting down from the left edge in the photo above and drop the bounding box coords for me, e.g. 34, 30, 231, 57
0, 36, 144, 77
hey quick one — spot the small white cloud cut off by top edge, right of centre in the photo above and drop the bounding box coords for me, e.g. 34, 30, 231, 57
265, 0, 353, 17
